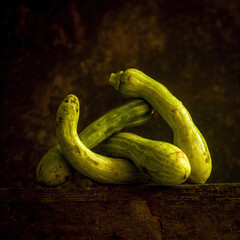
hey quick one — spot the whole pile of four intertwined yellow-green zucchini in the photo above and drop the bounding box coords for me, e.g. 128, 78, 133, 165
36, 69, 212, 187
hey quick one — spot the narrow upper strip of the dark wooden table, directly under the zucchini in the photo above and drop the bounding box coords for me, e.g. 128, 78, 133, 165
0, 183, 240, 203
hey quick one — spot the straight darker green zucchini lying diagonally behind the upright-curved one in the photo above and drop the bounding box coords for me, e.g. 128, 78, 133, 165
36, 99, 153, 187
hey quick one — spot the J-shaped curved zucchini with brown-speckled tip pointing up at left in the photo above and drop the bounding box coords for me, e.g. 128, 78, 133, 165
56, 94, 149, 184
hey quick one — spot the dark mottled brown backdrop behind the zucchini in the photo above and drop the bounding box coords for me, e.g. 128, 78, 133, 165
0, 0, 240, 188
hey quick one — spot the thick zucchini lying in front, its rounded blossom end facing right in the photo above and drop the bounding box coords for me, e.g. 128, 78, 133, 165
96, 132, 191, 186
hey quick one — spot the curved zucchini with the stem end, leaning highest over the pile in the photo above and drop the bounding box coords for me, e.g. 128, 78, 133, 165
109, 68, 212, 183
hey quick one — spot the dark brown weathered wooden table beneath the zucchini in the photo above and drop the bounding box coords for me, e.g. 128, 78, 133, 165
0, 183, 240, 240
